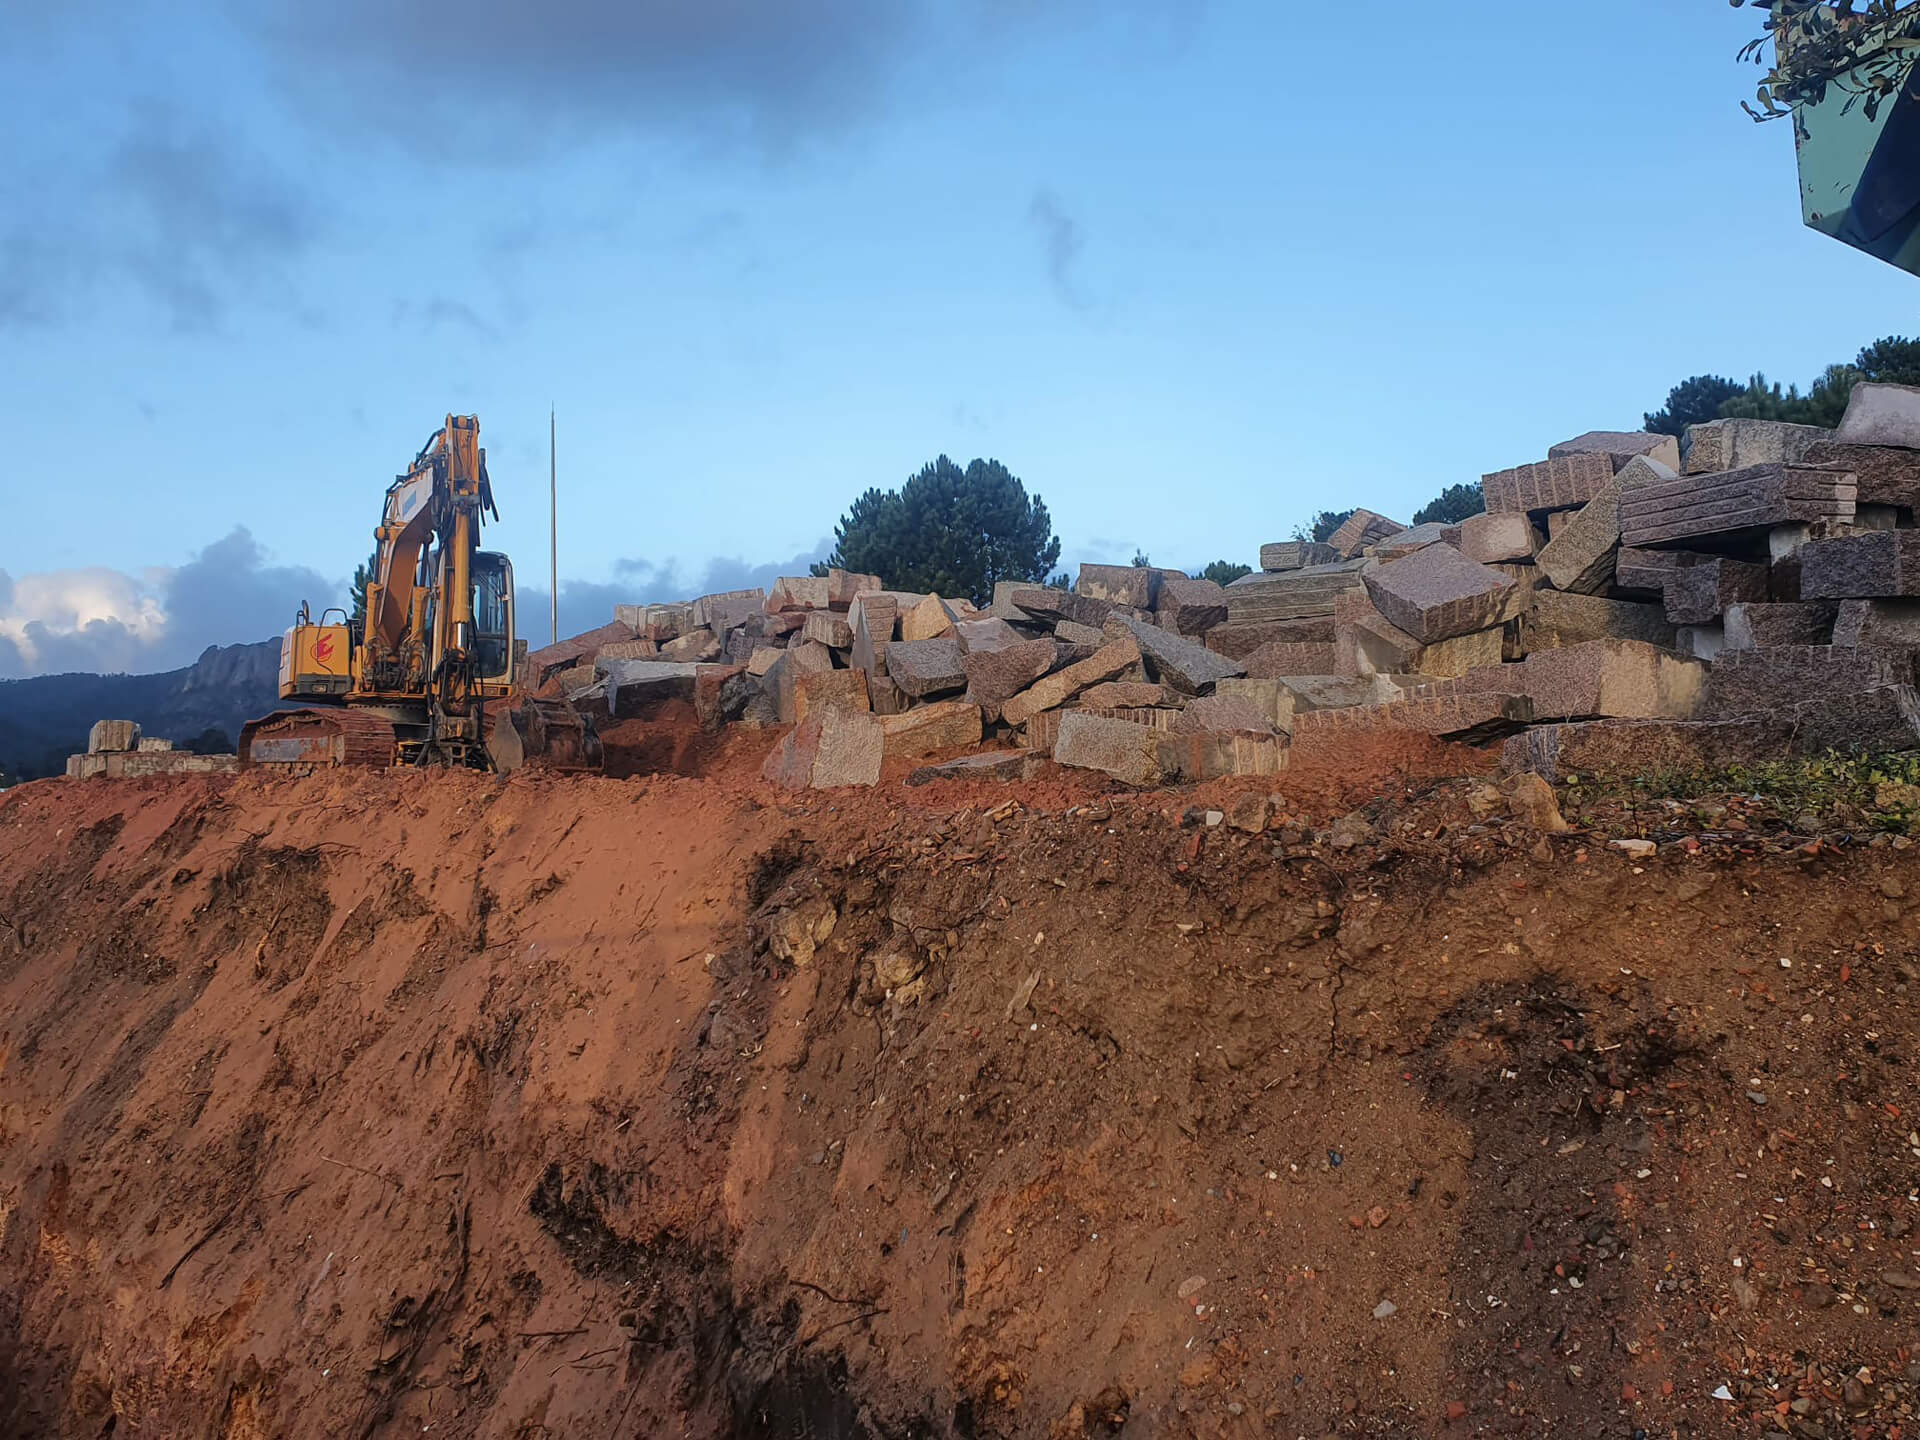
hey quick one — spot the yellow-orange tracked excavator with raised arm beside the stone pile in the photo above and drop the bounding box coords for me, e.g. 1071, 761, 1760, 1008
240, 415, 603, 772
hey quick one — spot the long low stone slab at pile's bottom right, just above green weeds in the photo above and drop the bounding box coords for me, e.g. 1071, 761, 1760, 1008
1501, 685, 1920, 783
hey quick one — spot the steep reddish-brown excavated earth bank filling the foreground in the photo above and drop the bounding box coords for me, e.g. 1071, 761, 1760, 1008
0, 721, 1920, 1440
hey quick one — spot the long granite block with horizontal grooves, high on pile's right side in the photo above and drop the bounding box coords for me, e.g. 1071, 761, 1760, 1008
1620, 465, 1855, 549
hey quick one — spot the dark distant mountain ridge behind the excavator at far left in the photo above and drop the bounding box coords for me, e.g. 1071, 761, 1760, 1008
0, 639, 280, 780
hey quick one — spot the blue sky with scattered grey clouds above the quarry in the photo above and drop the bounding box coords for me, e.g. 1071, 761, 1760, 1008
0, 0, 1920, 676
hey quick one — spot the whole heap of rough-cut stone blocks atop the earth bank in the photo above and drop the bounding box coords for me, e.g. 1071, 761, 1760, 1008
526, 384, 1920, 787
